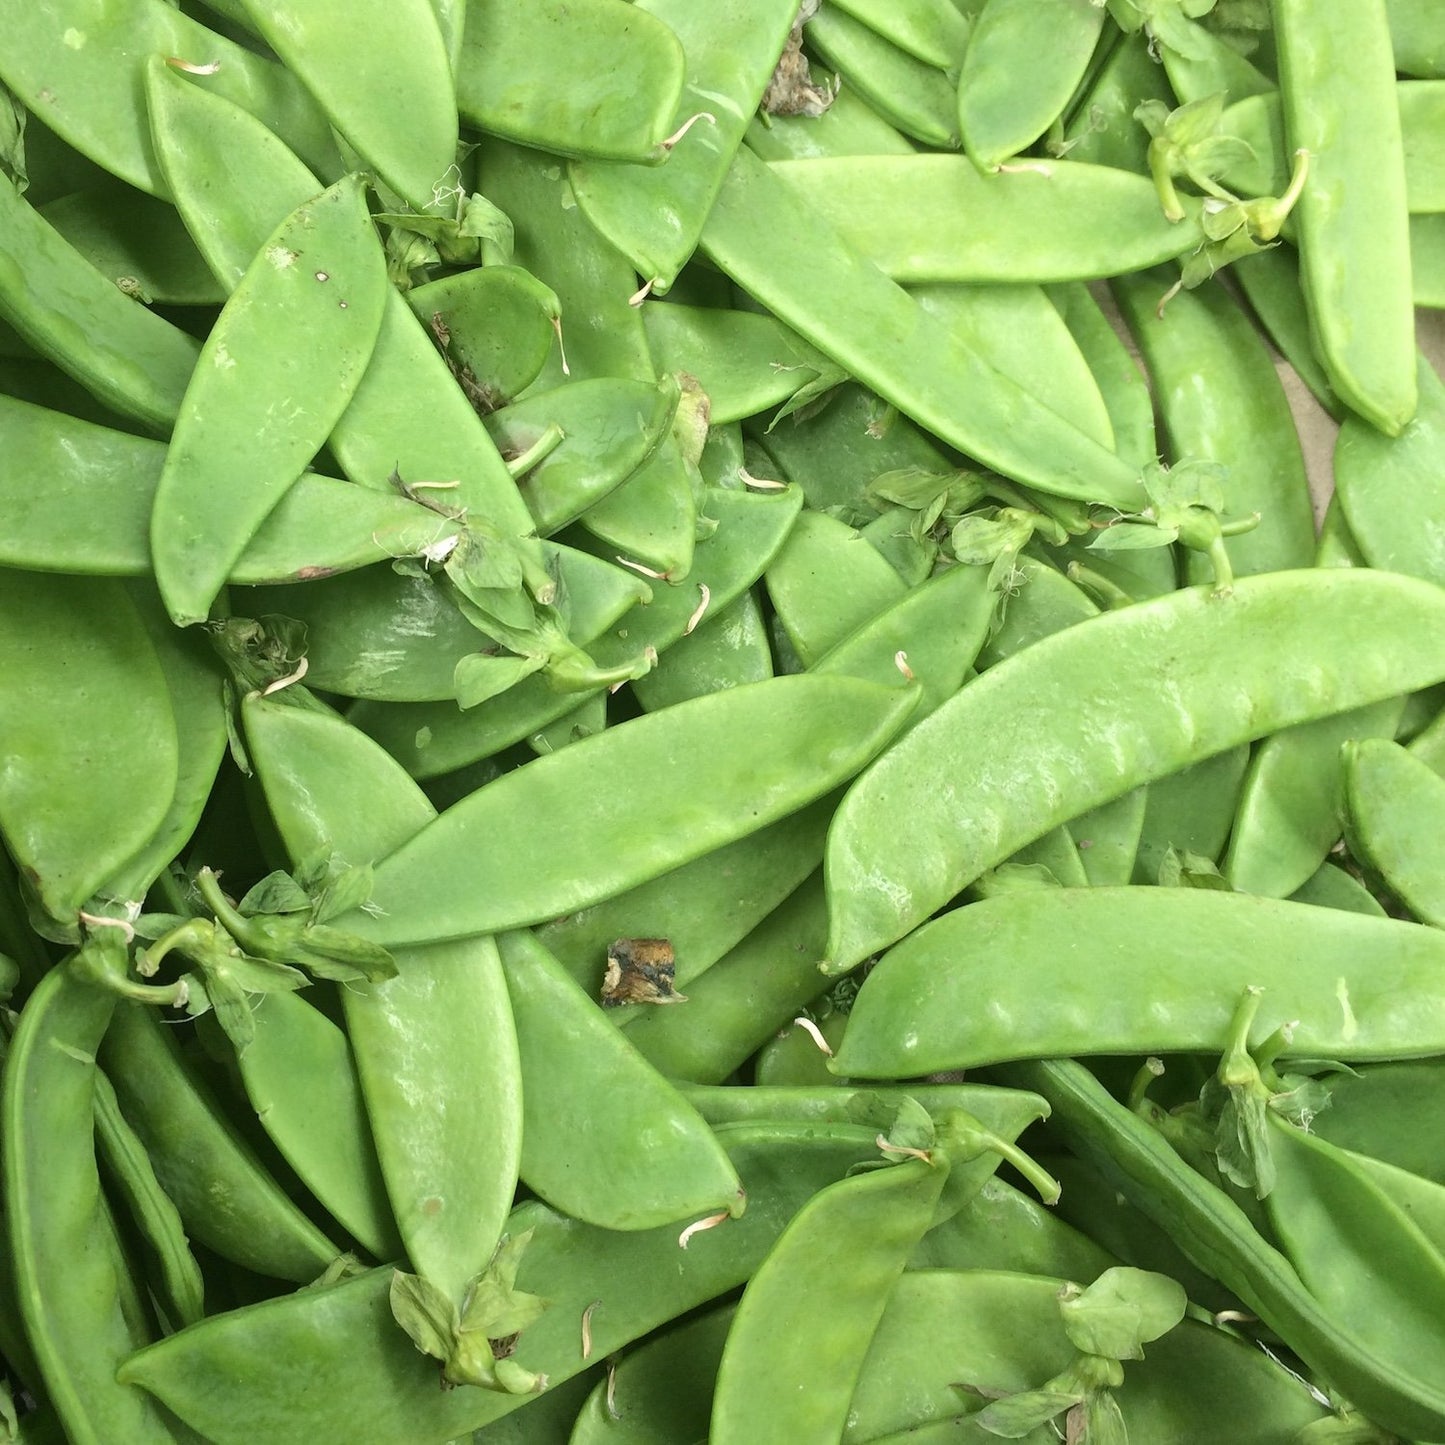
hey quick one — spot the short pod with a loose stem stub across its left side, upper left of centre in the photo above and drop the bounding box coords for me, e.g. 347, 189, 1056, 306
488, 375, 679, 536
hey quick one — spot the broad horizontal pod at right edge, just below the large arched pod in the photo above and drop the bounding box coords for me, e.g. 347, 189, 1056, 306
829, 884, 1445, 1078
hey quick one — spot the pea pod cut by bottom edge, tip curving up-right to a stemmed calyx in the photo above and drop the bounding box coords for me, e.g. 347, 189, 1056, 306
708, 1152, 948, 1445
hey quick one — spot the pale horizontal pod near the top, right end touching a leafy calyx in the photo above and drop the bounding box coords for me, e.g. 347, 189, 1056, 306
770, 156, 1202, 284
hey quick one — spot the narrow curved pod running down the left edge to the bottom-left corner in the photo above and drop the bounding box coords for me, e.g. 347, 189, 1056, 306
0, 964, 175, 1445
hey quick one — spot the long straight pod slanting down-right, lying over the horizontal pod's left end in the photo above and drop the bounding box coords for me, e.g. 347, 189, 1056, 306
702, 150, 1139, 507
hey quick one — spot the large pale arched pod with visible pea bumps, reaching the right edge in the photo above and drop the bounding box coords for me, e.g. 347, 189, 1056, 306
828, 569, 1445, 970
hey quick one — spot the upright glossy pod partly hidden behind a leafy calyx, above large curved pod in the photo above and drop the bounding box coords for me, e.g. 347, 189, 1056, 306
1111, 275, 1315, 582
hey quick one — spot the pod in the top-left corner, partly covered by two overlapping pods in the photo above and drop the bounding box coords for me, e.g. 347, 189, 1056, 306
0, 0, 337, 199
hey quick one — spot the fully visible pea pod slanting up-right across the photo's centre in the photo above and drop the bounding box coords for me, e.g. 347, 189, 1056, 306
345, 676, 918, 942
